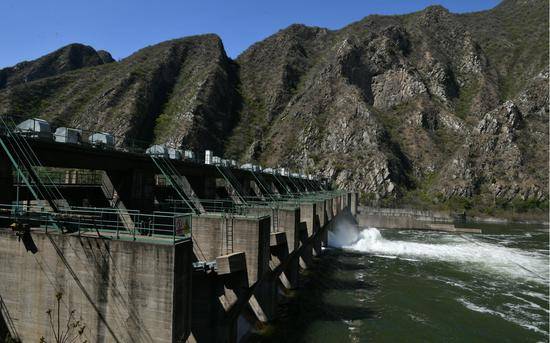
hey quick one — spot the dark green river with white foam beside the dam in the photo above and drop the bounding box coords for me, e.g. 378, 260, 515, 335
258, 225, 549, 342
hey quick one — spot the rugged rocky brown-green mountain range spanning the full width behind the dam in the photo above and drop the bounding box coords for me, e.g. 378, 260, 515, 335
0, 0, 549, 218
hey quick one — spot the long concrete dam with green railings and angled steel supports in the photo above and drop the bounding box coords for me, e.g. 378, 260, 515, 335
0, 117, 358, 342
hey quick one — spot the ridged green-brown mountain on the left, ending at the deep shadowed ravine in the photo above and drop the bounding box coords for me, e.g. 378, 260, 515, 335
0, 35, 237, 150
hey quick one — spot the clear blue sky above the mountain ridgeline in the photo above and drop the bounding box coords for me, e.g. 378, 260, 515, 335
0, 0, 499, 68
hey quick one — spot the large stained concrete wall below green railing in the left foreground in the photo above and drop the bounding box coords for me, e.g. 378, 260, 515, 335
0, 230, 192, 342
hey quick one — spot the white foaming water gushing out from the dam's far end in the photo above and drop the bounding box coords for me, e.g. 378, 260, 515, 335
329, 228, 549, 284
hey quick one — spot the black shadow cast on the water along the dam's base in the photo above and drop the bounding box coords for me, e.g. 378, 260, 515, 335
248, 250, 377, 342
